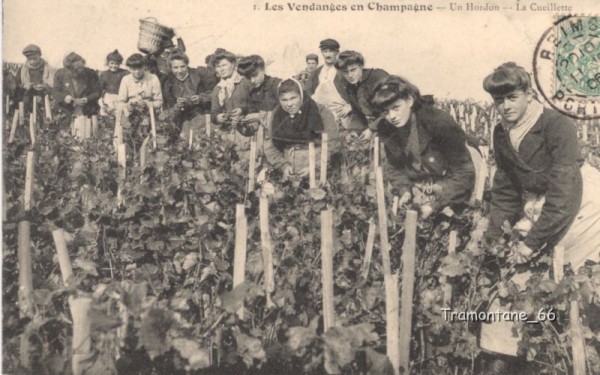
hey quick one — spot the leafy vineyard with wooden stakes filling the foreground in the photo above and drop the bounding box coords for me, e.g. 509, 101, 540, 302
2, 100, 600, 374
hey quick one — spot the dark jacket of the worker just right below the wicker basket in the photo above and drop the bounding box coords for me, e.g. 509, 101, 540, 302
162, 66, 219, 119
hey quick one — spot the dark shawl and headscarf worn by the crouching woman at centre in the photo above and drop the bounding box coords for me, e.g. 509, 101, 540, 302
271, 80, 324, 148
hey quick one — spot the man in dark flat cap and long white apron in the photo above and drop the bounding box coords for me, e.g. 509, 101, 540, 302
306, 39, 364, 132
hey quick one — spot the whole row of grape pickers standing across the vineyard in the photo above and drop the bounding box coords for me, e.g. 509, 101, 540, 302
4, 34, 600, 374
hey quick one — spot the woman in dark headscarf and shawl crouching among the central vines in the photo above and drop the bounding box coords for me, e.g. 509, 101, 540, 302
264, 78, 339, 179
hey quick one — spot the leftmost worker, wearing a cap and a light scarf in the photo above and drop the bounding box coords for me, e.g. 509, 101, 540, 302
17, 44, 55, 111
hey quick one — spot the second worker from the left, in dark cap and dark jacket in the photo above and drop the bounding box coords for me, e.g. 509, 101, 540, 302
52, 52, 102, 138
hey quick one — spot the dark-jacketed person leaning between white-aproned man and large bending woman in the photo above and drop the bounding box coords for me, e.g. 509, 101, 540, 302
334, 51, 389, 131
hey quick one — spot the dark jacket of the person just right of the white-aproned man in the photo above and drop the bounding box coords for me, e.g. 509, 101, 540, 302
345, 69, 389, 125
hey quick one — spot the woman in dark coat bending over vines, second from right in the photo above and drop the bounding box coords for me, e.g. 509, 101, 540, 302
370, 76, 475, 217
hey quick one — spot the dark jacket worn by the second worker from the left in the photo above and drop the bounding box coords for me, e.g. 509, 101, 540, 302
52, 68, 102, 116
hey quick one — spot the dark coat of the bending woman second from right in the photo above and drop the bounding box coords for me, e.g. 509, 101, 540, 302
379, 105, 475, 208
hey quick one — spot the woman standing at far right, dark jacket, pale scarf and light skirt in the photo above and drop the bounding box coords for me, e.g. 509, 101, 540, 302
480, 63, 600, 374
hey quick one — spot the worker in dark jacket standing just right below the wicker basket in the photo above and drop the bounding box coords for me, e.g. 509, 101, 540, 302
162, 52, 218, 137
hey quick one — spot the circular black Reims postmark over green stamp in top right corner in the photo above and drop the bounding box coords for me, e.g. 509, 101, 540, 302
533, 16, 600, 120
